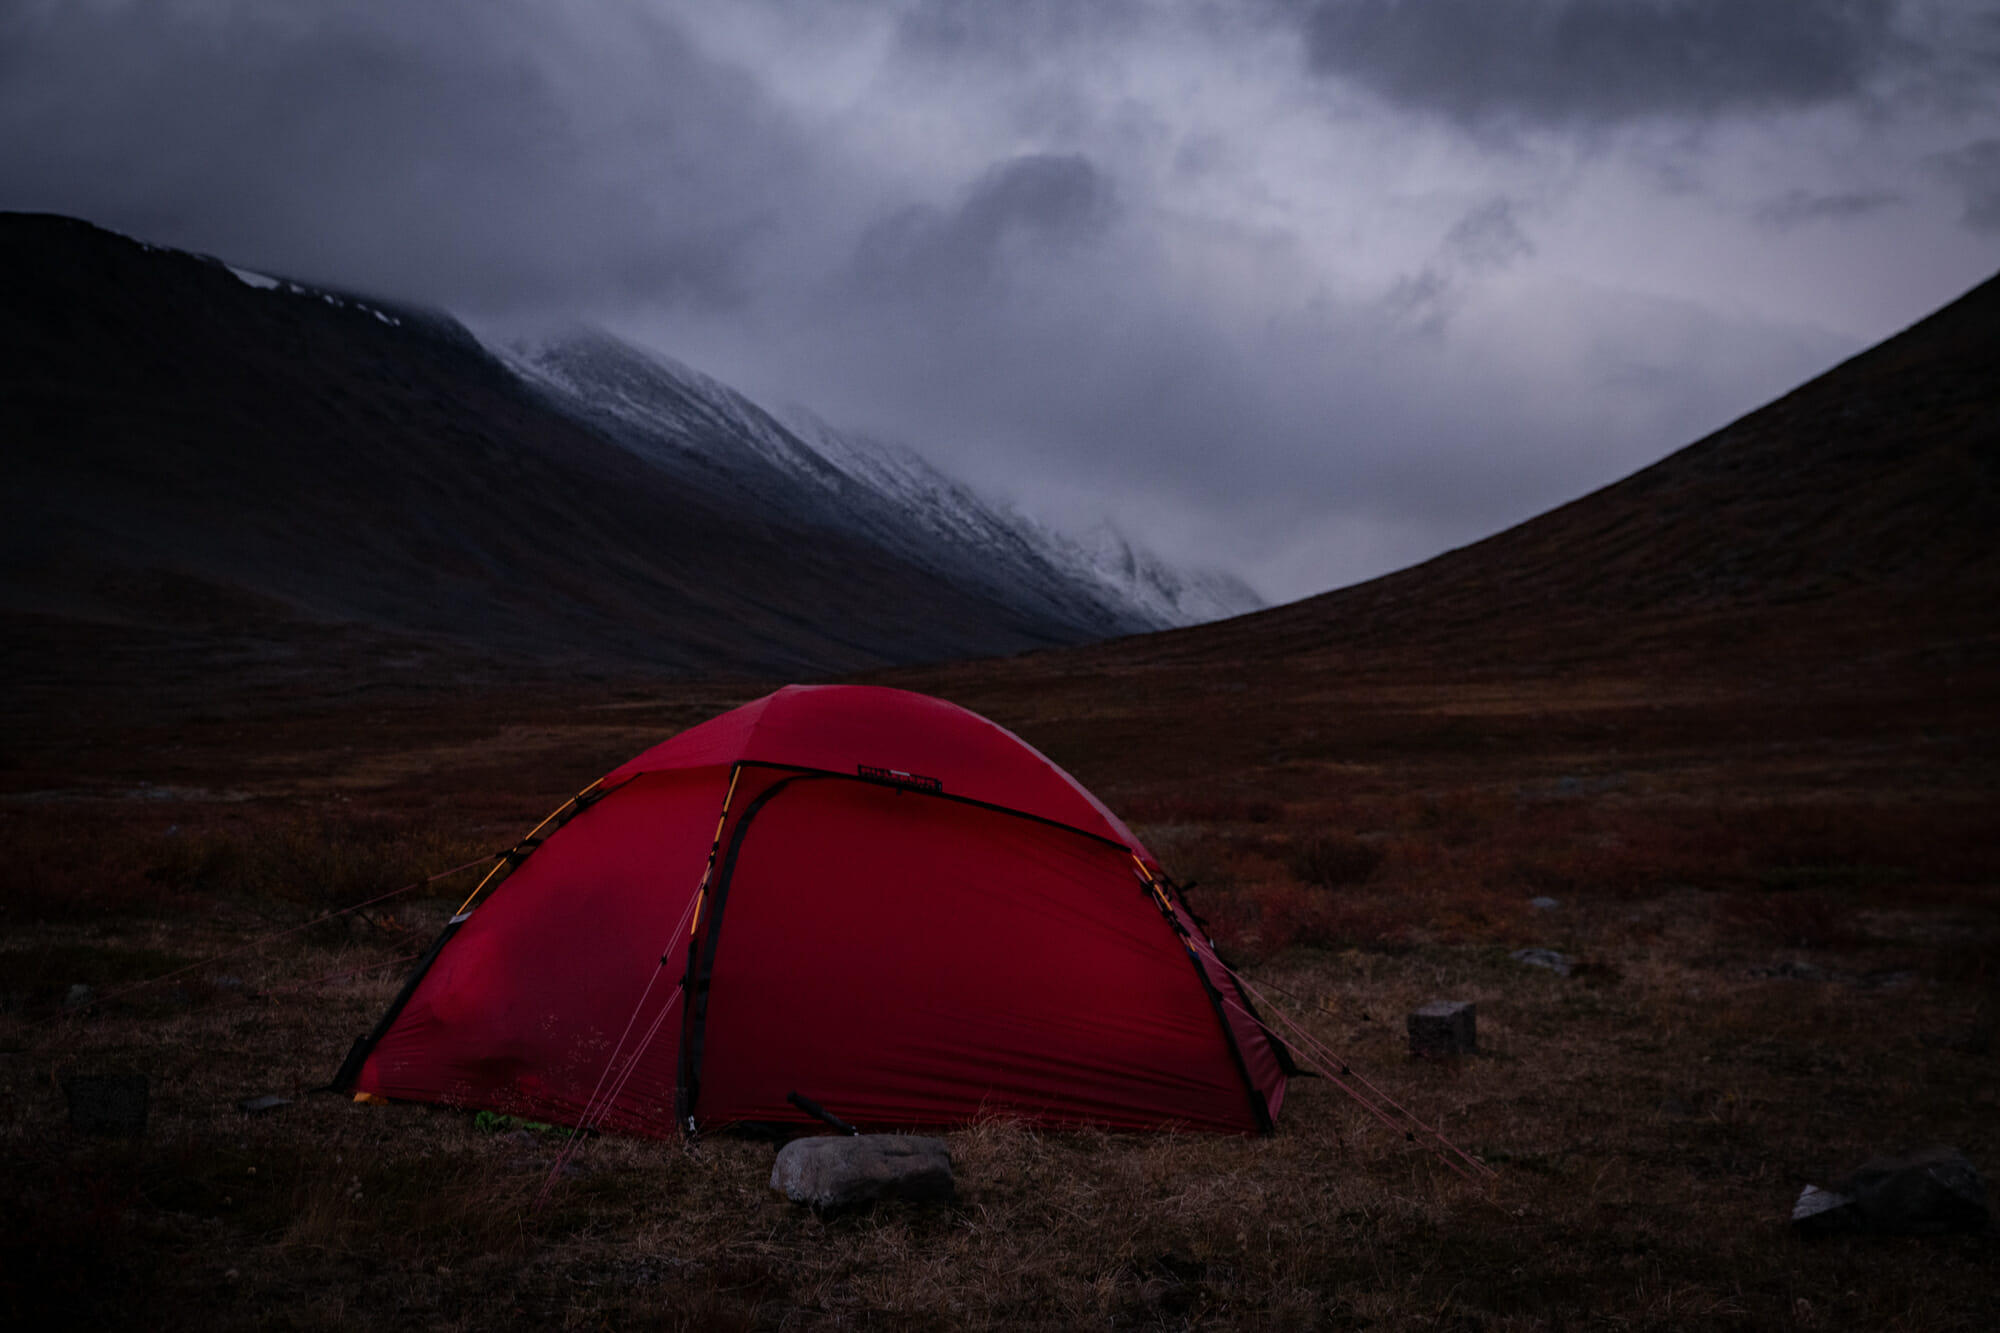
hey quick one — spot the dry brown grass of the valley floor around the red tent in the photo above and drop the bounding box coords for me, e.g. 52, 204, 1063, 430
0, 669, 2000, 1331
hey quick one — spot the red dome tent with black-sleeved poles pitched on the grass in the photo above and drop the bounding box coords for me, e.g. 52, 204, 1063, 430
334, 687, 1286, 1137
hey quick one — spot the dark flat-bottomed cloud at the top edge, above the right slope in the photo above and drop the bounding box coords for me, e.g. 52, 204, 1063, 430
1306, 0, 1898, 126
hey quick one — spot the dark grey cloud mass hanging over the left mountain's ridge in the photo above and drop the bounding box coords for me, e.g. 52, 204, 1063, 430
0, 0, 806, 312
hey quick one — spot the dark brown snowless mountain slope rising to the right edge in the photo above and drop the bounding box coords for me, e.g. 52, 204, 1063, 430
1140, 278, 2000, 662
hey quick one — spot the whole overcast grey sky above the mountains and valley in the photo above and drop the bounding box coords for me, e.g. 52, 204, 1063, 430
0, 0, 2000, 598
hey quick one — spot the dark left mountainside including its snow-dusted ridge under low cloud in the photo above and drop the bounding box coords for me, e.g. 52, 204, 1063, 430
0, 214, 1256, 675
